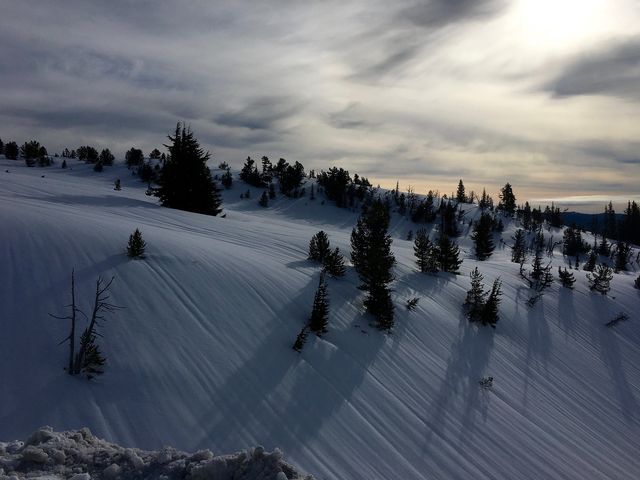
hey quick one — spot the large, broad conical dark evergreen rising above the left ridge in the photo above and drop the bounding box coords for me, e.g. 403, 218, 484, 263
158, 123, 222, 215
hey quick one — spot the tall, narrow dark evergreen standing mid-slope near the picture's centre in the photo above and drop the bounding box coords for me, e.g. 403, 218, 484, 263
351, 199, 396, 330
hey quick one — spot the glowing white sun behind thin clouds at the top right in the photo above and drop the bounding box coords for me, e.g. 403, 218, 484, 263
514, 0, 610, 48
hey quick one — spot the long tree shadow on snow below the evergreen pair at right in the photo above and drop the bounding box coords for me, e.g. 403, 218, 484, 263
426, 314, 495, 447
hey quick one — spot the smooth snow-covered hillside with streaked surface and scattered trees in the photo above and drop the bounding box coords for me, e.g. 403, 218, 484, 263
0, 160, 640, 479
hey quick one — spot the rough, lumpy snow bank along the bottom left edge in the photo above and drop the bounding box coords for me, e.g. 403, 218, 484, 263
0, 427, 313, 480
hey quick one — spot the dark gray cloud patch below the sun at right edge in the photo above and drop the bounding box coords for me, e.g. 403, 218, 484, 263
544, 36, 640, 100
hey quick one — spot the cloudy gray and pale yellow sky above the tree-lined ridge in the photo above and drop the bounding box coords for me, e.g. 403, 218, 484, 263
0, 0, 640, 209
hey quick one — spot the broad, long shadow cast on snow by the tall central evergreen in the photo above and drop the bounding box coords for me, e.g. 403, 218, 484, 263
198, 275, 384, 452
